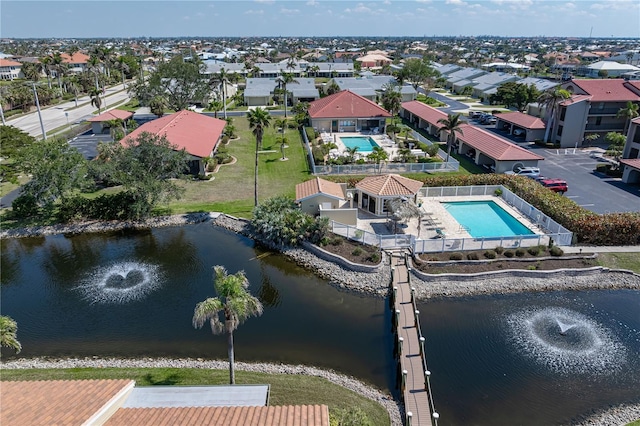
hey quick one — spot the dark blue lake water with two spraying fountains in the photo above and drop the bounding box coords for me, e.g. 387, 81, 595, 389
0, 223, 640, 425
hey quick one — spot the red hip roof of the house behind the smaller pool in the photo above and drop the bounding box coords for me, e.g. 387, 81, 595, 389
308, 90, 391, 118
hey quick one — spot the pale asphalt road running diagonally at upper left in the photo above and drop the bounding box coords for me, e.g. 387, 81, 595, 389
7, 84, 129, 137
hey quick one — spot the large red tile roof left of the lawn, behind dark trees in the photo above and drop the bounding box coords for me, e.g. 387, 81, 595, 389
120, 110, 227, 158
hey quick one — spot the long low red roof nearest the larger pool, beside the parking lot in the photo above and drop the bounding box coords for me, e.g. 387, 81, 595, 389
457, 124, 544, 161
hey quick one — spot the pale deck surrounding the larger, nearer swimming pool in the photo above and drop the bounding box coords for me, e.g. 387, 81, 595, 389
358, 195, 544, 239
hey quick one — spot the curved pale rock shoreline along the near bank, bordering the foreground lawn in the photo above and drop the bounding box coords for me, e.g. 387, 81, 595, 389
0, 357, 402, 426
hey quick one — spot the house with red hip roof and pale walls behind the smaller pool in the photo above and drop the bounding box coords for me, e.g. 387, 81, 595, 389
308, 90, 391, 133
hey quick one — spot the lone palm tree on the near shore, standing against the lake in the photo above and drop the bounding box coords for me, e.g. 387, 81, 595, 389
193, 265, 263, 385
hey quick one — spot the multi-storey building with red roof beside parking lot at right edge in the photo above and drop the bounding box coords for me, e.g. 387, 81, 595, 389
550, 79, 640, 147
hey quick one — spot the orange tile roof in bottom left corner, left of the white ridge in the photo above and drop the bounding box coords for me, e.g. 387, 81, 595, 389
0, 380, 135, 426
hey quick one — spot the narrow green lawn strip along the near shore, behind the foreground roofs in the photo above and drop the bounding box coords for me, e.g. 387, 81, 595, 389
2, 368, 390, 426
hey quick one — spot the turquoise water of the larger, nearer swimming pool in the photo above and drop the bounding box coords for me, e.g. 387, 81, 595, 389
442, 201, 533, 238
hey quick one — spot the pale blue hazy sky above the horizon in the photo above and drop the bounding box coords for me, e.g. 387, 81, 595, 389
0, 0, 640, 38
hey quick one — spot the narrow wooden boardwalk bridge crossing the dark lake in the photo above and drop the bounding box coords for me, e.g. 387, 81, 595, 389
391, 251, 437, 426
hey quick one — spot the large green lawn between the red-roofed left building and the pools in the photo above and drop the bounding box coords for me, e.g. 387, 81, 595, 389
168, 117, 311, 217
